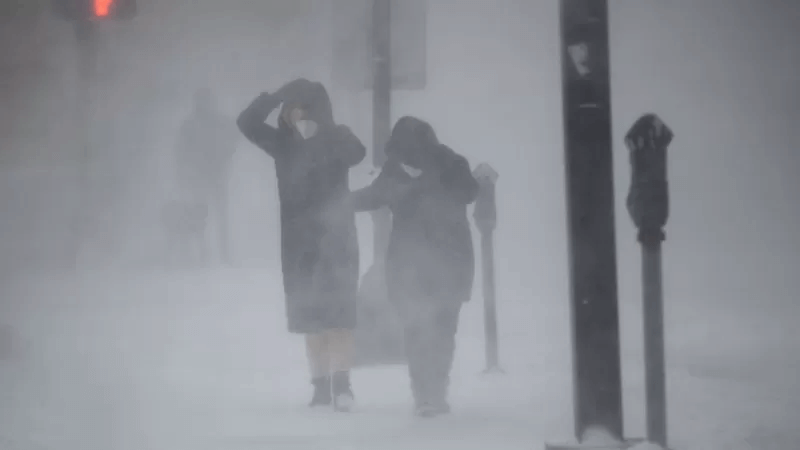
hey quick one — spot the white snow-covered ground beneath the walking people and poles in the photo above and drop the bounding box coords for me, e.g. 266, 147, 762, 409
0, 270, 800, 450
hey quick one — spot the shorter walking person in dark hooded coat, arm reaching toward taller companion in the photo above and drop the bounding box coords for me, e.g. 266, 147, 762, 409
351, 116, 478, 417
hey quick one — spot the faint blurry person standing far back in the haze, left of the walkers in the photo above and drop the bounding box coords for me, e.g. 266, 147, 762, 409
176, 88, 239, 264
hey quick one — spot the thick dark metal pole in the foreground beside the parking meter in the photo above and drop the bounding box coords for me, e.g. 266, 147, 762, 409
561, 0, 623, 442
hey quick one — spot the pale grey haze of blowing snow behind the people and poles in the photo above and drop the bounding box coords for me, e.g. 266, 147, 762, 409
0, 0, 800, 448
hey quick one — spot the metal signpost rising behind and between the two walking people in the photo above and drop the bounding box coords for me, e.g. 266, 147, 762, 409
372, 0, 392, 262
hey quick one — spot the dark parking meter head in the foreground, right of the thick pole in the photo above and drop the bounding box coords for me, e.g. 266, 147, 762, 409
625, 114, 673, 244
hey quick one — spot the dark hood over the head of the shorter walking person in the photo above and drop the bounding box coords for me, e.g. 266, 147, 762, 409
386, 116, 440, 168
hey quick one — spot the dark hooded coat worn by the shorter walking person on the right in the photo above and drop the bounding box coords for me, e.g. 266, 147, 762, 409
351, 117, 478, 302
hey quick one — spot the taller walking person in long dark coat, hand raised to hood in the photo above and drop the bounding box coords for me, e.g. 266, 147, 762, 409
237, 78, 366, 411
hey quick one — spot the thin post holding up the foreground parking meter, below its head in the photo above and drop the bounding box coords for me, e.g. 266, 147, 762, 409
642, 239, 667, 448
